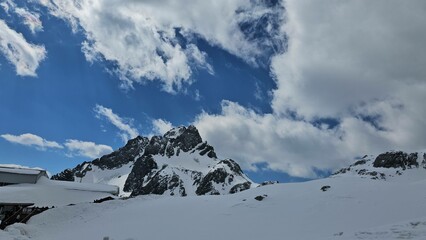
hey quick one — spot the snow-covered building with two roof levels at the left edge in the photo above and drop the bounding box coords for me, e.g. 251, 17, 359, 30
0, 165, 119, 229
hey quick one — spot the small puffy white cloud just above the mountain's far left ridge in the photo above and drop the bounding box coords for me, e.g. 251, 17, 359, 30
64, 139, 113, 159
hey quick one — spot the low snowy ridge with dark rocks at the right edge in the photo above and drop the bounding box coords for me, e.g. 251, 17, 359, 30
333, 151, 426, 180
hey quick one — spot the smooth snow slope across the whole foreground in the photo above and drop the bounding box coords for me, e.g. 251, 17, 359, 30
0, 169, 426, 240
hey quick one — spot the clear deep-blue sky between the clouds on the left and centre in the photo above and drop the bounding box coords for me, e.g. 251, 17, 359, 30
0, 1, 282, 181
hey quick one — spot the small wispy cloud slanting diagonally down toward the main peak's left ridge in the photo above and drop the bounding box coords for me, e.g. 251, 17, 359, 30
94, 105, 139, 142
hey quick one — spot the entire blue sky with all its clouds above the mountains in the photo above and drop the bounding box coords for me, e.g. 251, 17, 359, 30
0, 0, 426, 182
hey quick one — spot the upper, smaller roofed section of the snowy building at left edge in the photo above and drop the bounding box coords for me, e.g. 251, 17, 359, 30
0, 166, 48, 186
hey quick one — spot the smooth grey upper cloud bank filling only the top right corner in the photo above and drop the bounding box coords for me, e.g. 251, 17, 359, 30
272, 0, 426, 119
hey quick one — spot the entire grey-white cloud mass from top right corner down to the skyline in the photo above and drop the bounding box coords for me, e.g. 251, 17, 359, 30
195, 0, 426, 177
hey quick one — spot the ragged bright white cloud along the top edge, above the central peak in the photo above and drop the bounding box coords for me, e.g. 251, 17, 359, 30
38, 0, 282, 93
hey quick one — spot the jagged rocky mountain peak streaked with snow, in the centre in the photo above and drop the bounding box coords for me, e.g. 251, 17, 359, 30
52, 126, 255, 196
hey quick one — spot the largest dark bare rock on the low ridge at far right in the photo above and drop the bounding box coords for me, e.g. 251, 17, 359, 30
373, 151, 419, 170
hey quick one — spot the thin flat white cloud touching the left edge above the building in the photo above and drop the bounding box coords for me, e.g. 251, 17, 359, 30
0, 133, 64, 150
